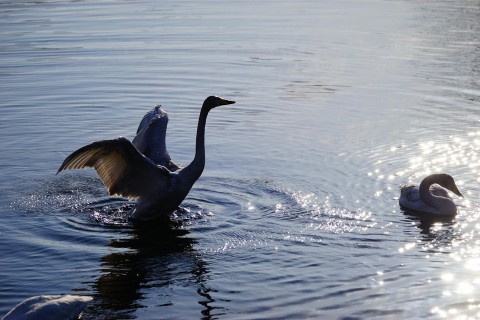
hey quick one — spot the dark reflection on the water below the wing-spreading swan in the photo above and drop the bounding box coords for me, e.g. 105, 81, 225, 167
83, 216, 218, 319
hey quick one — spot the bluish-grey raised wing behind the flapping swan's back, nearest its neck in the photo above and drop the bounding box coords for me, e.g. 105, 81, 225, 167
132, 106, 179, 171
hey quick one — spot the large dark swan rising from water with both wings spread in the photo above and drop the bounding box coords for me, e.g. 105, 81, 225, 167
57, 96, 235, 221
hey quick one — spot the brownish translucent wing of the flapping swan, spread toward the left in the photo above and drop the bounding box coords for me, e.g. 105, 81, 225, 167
57, 138, 169, 198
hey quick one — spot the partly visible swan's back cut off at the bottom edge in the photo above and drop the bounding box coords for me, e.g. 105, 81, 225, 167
2, 294, 92, 320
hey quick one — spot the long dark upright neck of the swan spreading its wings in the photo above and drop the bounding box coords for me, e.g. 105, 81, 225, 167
181, 106, 209, 185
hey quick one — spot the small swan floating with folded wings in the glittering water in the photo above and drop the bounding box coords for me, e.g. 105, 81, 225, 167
398, 173, 463, 216
